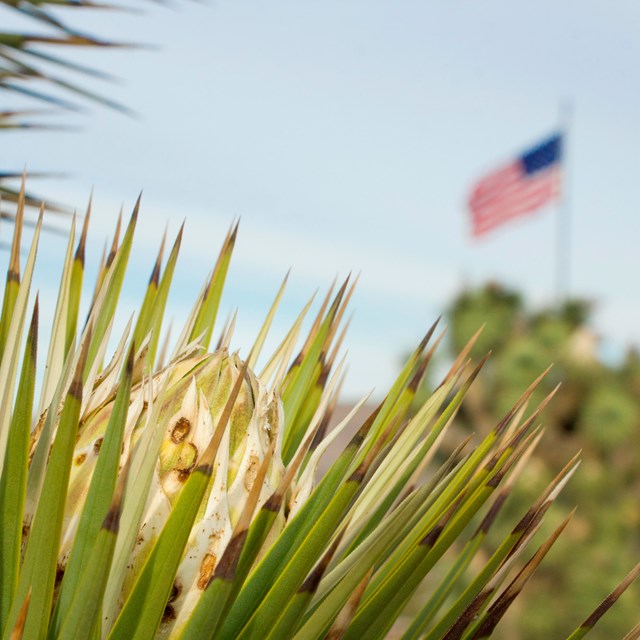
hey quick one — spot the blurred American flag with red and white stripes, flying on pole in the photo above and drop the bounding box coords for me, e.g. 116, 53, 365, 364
469, 134, 562, 236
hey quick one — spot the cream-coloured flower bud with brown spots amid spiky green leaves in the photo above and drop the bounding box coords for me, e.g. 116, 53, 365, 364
52, 349, 284, 637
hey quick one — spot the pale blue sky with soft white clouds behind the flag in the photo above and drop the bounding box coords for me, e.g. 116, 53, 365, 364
0, 0, 640, 395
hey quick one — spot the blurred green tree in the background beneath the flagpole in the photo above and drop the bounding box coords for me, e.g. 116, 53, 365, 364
426, 283, 640, 640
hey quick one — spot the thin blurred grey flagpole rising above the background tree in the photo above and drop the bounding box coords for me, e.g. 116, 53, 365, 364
555, 102, 572, 305
